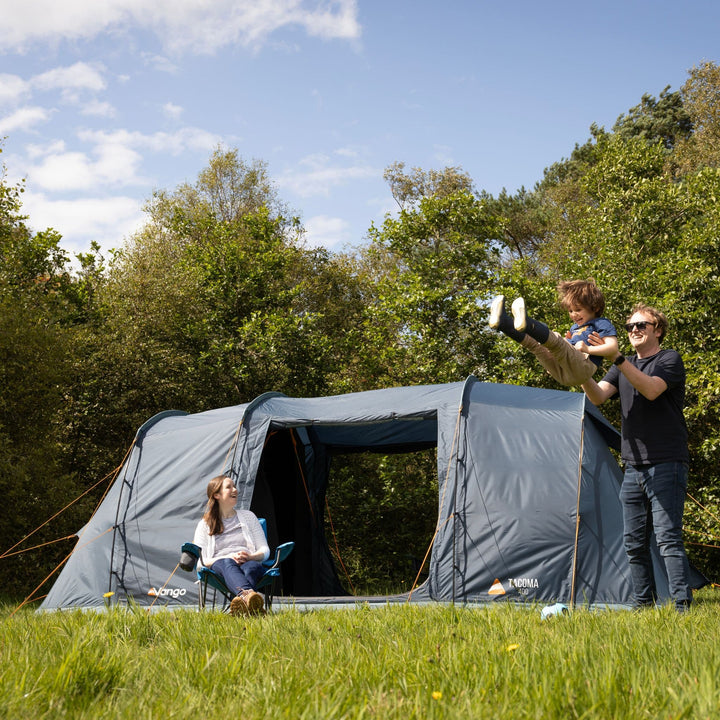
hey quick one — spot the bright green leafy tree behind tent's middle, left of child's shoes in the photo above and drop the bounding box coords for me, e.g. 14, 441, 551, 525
346, 166, 499, 387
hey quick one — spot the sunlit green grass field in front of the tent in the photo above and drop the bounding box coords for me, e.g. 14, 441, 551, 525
0, 590, 720, 720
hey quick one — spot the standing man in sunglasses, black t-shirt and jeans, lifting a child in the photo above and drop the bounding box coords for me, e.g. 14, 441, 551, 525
582, 304, 692, 612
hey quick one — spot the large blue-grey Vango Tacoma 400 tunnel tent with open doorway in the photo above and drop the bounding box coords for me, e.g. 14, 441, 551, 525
42, 376, 680, 609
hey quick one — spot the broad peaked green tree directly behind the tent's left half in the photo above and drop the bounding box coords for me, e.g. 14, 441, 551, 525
62, 151, 366, 478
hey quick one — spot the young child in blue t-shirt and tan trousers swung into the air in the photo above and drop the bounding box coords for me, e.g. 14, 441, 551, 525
489, 279, 618, 385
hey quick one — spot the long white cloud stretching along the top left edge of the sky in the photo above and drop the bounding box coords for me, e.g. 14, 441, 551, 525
0, 0, 361, 53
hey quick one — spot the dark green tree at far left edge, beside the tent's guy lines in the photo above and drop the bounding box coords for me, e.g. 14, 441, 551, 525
0, 148, 90, 588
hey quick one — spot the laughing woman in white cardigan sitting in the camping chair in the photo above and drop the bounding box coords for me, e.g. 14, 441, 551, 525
194, 475, 270, 615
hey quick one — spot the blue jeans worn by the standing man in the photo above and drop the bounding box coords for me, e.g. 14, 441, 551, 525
620, 462, 692, 610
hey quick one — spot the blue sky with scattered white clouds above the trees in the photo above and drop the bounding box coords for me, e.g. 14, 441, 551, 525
0, 0, 720, 255
